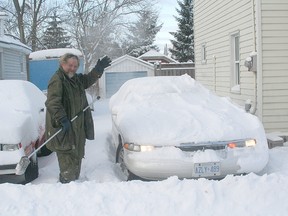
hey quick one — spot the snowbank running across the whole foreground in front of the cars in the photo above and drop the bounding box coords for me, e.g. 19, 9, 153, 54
0, 174, 288, 216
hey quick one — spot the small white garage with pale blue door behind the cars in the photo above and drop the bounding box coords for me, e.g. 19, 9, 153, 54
99, 55, 154, 98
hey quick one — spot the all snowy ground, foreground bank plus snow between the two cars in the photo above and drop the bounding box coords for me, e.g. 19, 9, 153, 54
0, 100, 288, 216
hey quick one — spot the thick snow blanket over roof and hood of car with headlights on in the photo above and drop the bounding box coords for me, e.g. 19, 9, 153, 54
110, 75, 266, 146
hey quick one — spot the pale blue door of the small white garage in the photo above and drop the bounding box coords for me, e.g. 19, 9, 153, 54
105, 71, 147, 98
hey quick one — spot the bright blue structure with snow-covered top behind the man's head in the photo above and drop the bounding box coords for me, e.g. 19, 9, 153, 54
29, 48, 84, 90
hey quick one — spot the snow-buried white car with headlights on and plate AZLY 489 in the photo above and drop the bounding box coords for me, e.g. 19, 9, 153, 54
109, 75, 268, 180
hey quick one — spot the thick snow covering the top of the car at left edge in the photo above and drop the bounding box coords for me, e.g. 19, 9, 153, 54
0, 80, 46, 146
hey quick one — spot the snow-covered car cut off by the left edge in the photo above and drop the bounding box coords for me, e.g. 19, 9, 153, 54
0, 80, 46, 183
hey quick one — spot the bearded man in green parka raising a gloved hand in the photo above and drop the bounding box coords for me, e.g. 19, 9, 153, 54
45, 53, 111, 183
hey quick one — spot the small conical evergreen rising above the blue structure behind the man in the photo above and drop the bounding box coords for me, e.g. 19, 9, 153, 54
42, 13, 71, 49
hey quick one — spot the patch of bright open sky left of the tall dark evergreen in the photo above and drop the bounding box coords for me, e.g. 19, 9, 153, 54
155, 0, 179, 52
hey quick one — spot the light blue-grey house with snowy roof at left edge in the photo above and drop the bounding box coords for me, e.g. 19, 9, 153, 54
0, 12, 31, 80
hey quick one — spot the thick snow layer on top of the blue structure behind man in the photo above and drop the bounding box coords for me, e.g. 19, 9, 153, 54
29, 48, 83, 60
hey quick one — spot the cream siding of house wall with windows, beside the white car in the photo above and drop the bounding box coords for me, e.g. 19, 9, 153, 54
194, 0, 255, 106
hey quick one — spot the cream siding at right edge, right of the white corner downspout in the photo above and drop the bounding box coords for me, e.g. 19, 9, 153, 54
260, 0, 288, 132
